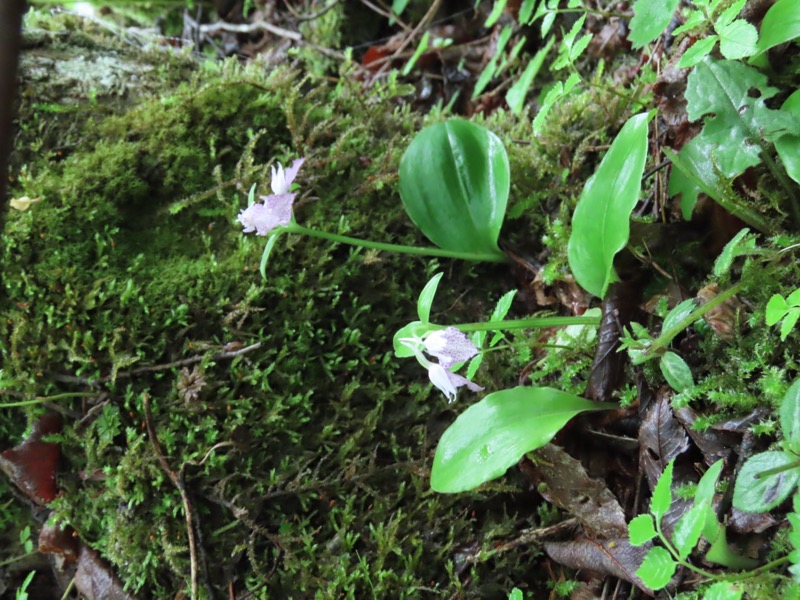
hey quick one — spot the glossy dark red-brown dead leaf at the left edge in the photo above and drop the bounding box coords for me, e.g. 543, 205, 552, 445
0, 413, 61, 505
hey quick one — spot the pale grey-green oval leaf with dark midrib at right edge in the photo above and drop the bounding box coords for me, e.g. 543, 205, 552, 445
733, 452, 800, 513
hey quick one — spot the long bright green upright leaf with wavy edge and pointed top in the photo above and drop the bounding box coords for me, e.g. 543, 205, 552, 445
567, 113, 650, 298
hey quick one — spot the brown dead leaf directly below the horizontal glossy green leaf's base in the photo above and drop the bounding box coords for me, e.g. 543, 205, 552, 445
532, 444, 628, 539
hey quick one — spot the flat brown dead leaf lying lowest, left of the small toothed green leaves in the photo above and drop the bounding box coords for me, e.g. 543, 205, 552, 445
544, 539, 655, 596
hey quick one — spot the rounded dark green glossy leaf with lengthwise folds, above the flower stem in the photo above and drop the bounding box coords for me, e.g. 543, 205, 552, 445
400, 119, 510, 257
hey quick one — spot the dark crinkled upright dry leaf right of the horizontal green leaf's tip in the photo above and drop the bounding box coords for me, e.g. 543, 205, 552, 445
639, 386, 689, 490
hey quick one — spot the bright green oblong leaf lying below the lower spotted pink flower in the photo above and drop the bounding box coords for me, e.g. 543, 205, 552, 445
431, 387, 616, 493
